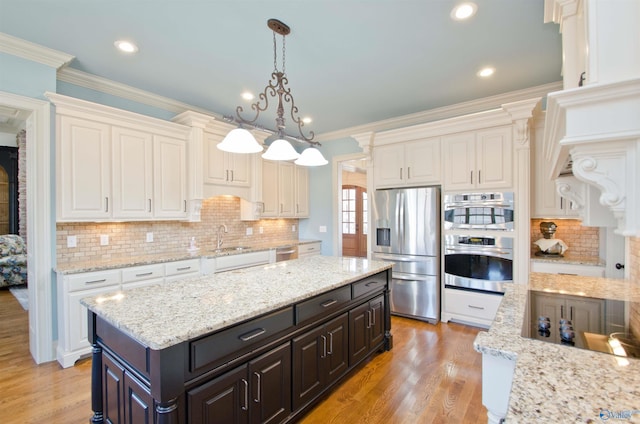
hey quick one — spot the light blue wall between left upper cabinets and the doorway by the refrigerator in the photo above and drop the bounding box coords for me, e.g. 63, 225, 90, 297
299, 138, 362, 256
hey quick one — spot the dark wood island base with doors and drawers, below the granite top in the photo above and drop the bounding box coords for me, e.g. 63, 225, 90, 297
90, 270, 392, 424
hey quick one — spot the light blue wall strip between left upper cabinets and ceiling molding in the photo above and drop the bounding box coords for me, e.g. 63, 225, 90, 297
56, 81, 176, 121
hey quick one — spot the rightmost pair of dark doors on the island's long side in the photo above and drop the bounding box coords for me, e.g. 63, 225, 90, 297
349, 296, 384, 366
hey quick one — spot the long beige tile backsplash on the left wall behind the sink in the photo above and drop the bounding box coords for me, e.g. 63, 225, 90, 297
56, 196, 298, 264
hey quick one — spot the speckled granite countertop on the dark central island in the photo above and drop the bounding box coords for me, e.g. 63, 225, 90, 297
81, 256, 391, 350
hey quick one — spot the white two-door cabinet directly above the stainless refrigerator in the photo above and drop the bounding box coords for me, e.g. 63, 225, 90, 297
373, 137, 442, 188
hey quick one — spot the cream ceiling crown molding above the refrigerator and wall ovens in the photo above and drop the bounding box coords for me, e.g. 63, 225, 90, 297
316, 81, 562, 141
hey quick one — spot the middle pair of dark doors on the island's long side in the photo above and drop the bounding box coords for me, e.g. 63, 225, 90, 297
292, 313, 349, 410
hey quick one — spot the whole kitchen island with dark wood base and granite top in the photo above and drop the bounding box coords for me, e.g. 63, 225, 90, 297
82, 256, 392, 423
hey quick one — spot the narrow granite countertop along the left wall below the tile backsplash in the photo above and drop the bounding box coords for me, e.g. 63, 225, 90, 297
53, 240, 321, 274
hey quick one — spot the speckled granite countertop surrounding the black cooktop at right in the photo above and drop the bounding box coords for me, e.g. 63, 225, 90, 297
474, 273, 640, 423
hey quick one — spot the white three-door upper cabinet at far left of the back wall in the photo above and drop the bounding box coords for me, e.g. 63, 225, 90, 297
48, 93, 188, 222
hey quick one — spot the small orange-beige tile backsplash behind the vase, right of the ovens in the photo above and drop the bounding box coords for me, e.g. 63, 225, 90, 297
531, 219, 600, 257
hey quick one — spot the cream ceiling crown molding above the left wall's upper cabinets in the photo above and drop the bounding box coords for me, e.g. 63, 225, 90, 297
58, 68, 215, 119
